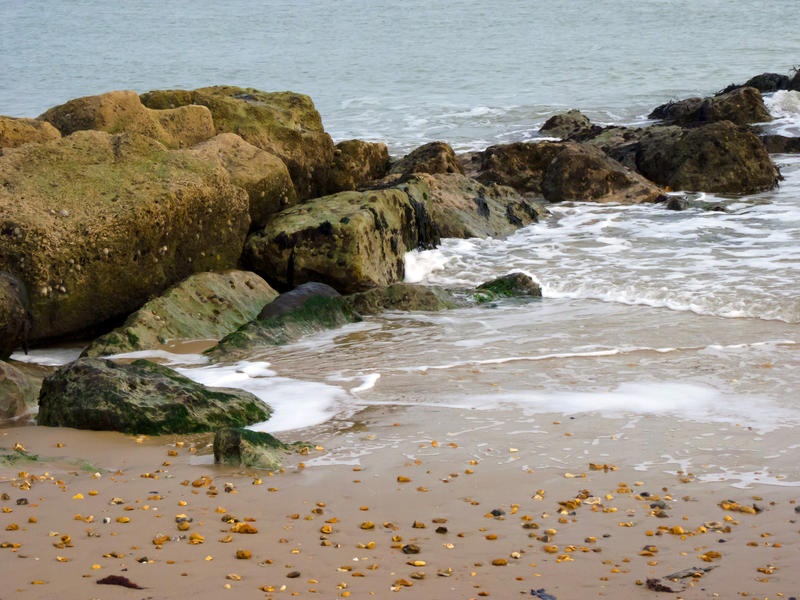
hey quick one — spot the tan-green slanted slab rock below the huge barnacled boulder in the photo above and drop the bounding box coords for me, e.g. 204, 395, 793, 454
83, 271, 278, 356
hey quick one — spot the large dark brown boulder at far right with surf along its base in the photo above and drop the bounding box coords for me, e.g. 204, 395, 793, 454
636, 121, 780, 194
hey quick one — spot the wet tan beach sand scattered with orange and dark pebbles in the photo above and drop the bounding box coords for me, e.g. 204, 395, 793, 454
0, 407, 800, 600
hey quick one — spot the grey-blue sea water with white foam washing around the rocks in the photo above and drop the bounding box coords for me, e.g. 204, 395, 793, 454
6, 0, 800, 485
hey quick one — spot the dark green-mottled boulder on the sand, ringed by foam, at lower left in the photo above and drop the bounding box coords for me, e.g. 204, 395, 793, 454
37, 358, 270, 435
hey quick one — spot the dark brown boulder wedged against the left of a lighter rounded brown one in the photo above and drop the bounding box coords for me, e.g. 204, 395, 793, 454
477, 142, 565, 194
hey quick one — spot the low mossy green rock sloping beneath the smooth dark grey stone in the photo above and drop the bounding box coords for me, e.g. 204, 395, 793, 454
206, 295, 361, 361
